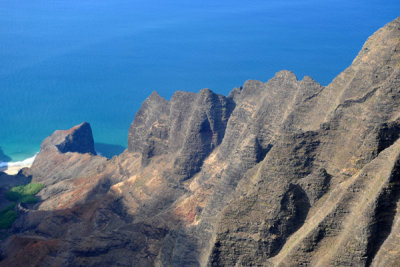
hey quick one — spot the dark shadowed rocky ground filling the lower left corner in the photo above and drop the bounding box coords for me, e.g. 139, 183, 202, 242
0, 157, 196, 266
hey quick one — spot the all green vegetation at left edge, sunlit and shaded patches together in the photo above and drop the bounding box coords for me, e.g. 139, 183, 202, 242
0, 183, 43, 229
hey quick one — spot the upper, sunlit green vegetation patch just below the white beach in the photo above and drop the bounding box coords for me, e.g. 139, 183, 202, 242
6, 183, 43, 204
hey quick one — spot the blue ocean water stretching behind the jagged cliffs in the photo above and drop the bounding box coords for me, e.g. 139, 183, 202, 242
0, 0, 400, 161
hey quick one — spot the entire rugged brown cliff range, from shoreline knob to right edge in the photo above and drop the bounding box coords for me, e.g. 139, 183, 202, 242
0, 18, 400, 266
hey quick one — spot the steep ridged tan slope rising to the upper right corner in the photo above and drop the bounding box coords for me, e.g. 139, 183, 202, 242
209, 19, 400, 266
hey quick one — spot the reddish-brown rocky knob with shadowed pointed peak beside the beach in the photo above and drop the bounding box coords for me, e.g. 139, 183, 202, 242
28, 122, 107, 209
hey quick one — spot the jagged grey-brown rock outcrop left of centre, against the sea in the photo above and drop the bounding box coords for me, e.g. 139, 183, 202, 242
128, 89, 235, 178
